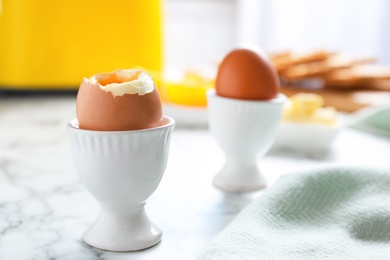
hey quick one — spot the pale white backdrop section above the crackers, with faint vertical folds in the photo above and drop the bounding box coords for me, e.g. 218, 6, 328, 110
238, 0, 390, 65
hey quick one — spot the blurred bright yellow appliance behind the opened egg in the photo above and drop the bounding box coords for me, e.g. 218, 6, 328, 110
0, 0, 162, 89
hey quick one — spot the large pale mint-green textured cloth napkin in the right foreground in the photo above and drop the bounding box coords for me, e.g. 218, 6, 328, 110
198, 167, 390, 260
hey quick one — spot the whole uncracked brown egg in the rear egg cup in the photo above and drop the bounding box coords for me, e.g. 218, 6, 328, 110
215, 49, 280, 100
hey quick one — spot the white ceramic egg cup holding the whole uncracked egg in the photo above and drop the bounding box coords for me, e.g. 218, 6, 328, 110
207, 89, 286, 192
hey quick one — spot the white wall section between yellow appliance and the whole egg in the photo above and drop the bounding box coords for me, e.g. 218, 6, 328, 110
164, 0, 237, 71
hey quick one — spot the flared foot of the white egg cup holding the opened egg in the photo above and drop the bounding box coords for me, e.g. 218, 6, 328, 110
83, 206, 162, 252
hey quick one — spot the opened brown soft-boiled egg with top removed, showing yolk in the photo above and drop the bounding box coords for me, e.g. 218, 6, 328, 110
76, 70, 163, 131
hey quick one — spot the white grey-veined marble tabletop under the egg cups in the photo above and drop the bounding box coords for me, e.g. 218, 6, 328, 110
0, 96, 390, 260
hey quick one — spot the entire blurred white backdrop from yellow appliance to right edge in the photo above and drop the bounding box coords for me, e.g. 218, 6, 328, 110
165, 0, 390, 68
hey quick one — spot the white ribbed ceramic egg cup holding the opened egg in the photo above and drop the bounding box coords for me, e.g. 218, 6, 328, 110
68, 116, 175, 251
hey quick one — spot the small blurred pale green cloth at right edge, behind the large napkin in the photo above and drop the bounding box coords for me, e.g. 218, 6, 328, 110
349, 105, 390, 136
